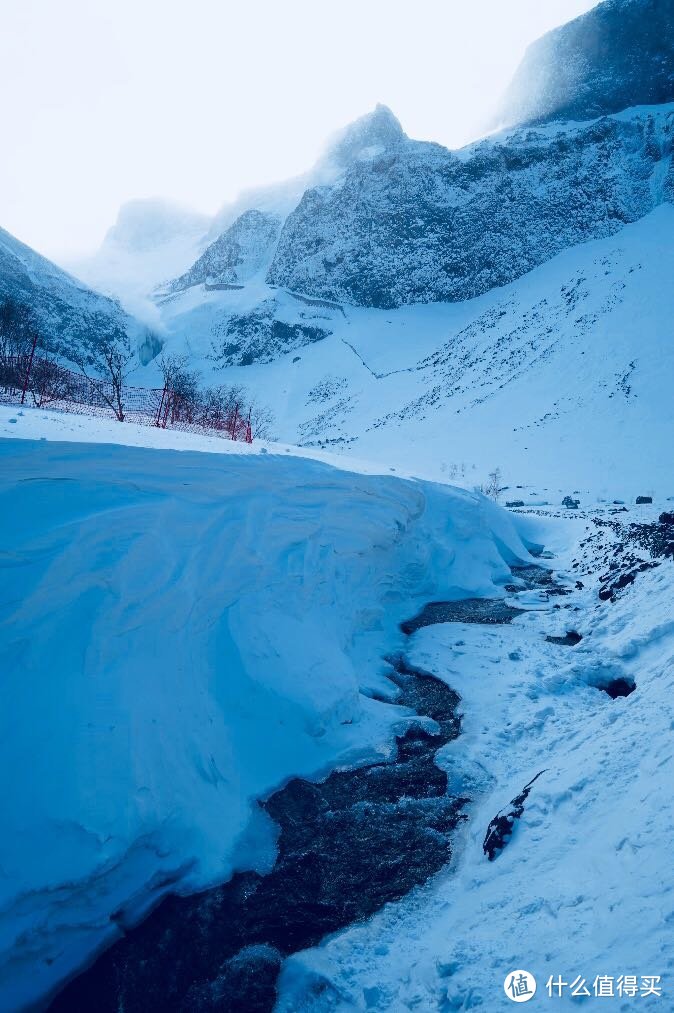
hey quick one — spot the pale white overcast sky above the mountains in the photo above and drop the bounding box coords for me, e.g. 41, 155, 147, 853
0, 0, 596, 259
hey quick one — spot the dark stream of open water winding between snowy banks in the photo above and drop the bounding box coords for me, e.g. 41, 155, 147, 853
50, 567, 547, 1013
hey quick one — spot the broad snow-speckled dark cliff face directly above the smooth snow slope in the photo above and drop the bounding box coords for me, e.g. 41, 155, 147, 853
268, 108, 674, 308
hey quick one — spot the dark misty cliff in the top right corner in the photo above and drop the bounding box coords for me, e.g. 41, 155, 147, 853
499, 0, 674, 124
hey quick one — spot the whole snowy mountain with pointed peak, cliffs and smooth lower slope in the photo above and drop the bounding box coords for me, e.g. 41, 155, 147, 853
6, 0, 674, 494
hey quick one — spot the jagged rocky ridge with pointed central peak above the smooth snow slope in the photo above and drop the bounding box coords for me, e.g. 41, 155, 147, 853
49, 0, 674, 382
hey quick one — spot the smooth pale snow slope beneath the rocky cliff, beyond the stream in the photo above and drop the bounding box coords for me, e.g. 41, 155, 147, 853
151, 206, 674, 502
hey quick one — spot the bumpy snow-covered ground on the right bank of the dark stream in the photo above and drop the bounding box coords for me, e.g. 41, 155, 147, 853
277, 512, 674, 1013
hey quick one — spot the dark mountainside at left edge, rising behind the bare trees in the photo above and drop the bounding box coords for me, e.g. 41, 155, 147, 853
0, 223, 151, 361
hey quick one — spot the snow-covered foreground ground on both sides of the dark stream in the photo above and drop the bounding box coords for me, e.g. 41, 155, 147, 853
0, 408, 674, 1013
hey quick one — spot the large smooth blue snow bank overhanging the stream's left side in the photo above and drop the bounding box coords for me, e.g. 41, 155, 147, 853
0, 412, 526, 1009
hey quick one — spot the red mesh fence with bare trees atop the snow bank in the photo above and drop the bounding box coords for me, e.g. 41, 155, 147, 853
0, 348, 252, 443
